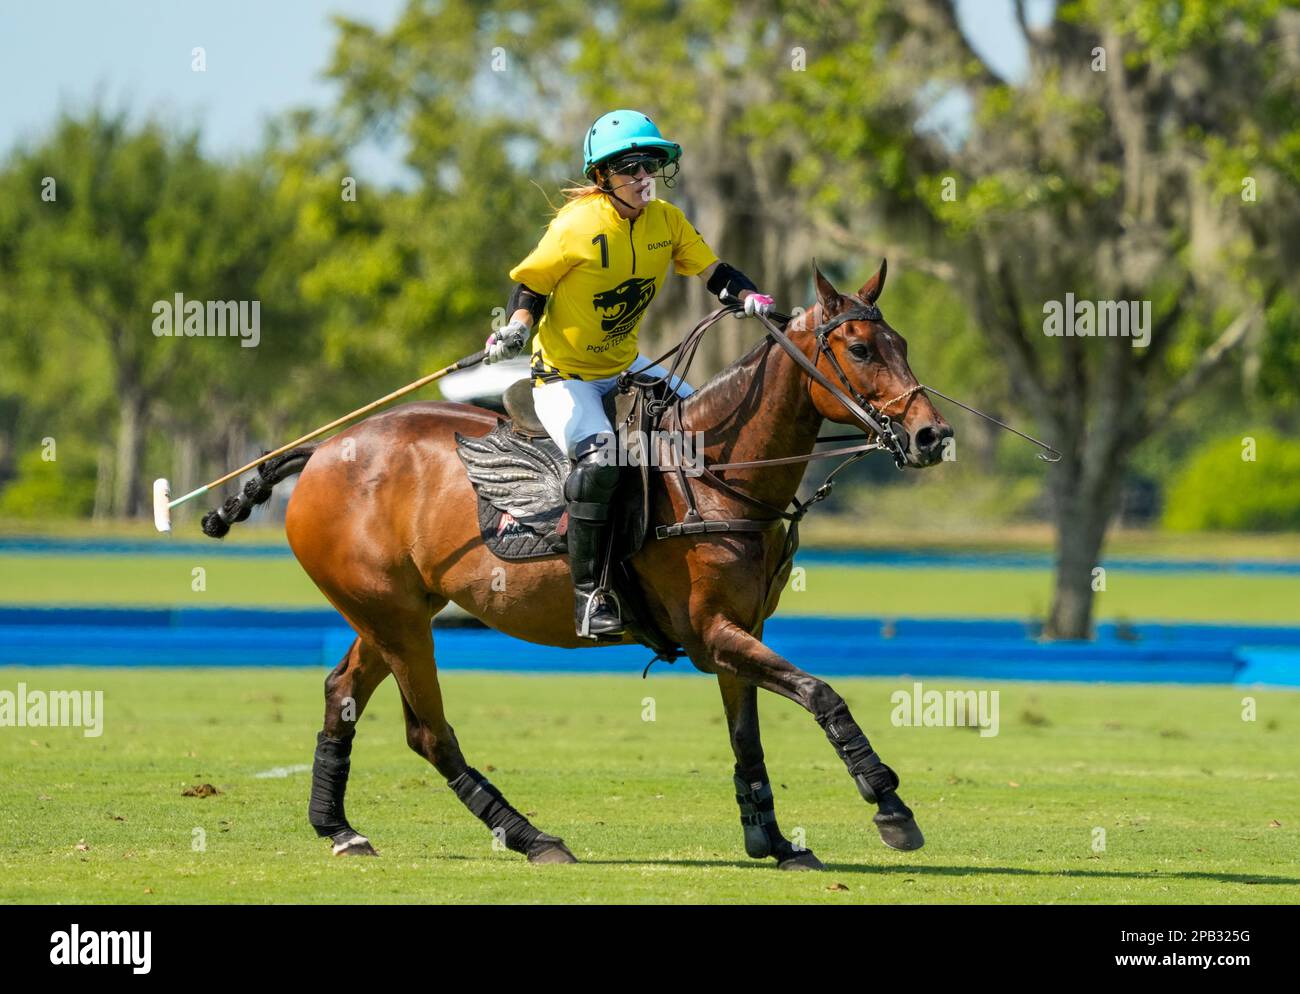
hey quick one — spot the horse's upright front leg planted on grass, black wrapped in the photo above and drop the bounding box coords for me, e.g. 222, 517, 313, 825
718, 673, 824, 869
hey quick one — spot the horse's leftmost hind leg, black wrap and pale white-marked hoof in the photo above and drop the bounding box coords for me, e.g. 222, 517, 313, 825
307, 638, 389, 856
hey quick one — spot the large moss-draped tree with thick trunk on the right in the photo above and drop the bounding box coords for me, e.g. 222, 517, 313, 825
767, 0, 1300, 638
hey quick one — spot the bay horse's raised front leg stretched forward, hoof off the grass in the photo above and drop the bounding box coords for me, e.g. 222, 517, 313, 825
699, 617, 926, 850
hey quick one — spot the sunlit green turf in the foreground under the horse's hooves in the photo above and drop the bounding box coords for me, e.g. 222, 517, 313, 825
0, 668, 1300, 904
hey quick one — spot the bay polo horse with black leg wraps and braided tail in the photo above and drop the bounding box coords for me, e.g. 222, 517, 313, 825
218, 262, 953, 869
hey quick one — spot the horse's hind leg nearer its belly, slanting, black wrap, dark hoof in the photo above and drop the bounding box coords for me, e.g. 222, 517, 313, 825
384, 621, 577, 863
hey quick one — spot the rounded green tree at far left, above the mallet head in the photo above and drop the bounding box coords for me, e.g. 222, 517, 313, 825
0, 108, 316, 516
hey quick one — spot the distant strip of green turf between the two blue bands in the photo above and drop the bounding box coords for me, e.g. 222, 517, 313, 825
0, 555, 1300, 624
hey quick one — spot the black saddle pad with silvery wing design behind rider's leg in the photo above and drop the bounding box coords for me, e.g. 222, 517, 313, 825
456, 421, 569, 560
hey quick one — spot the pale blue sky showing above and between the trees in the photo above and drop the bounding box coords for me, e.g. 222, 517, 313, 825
0, 0, 1050, 178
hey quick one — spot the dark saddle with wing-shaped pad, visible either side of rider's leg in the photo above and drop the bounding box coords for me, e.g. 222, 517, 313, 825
455, 376, 681, 661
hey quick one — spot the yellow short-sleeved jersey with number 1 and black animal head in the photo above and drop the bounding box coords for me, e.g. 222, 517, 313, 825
510, 194, 718, 385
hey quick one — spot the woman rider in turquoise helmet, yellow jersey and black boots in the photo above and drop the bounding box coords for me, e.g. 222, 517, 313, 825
484, 110, 772, 638
